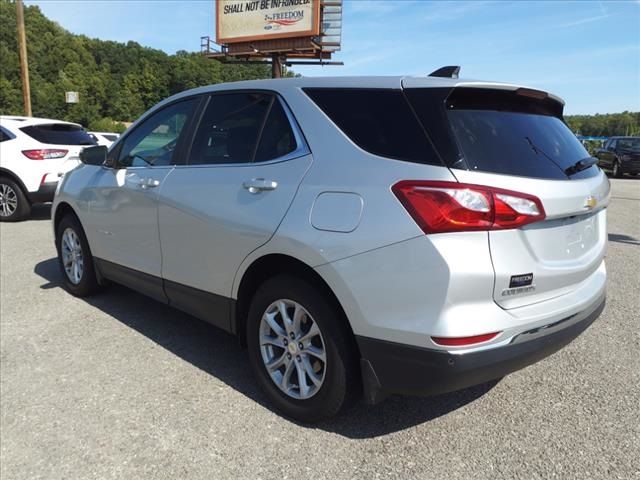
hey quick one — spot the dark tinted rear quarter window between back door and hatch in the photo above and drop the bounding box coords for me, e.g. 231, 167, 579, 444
304, 88, 441, 165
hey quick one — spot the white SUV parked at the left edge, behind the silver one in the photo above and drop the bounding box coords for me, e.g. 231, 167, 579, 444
0, 116, 96, 222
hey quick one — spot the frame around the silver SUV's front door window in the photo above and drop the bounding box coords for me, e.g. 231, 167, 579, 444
110, 94, 206, 170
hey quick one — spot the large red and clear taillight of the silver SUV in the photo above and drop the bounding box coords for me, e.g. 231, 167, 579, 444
391, 180, 545, 233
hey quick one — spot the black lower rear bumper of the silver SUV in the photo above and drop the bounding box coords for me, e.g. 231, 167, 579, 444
357, 295, 605, 403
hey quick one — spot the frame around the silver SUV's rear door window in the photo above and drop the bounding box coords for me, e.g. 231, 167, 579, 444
175, 89, 311, 168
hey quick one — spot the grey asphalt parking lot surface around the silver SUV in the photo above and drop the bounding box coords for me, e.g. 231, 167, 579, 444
0, 178, 640, 480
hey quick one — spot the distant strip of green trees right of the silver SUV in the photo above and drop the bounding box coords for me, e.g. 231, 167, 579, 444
565, 112, 640, 137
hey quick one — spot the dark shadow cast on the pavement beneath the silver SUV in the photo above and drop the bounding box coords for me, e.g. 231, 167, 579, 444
34, 258, 498, 438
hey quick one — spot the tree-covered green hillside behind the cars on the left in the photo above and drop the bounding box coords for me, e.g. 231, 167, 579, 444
0, 0, 270, 127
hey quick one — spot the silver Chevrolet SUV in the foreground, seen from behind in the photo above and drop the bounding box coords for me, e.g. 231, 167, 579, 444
53, 71, 609, 422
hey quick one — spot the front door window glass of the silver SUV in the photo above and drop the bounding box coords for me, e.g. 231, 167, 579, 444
118, 99, 198, 167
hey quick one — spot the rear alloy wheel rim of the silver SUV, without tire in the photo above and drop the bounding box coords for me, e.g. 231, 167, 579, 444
259, 299, 327, 400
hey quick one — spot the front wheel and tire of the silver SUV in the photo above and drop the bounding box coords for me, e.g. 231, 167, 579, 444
56, 214, 100, 297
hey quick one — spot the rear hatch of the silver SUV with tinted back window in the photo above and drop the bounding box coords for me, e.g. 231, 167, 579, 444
405, 85, 609, 309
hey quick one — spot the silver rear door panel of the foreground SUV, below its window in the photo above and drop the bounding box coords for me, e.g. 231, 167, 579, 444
159, 155, 312, 296
